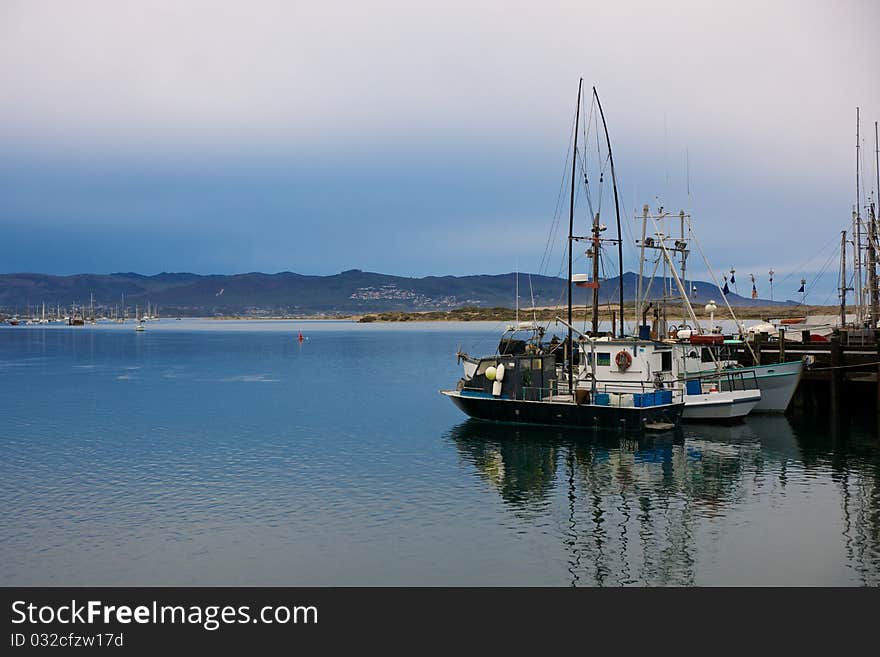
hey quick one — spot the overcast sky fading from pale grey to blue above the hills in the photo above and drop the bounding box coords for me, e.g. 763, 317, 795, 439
0, 0, 880, 303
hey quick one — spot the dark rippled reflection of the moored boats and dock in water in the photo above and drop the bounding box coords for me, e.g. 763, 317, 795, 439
449, 416, 880, 586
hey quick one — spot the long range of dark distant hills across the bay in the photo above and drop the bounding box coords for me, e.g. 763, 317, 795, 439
0, 269, 795, 316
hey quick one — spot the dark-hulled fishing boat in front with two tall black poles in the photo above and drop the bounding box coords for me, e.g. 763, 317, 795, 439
440, 80, 684, 433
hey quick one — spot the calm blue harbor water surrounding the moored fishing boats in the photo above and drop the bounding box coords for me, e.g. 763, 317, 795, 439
0, 320, 880, 586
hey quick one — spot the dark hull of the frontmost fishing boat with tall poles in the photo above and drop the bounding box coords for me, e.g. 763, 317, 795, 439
440, 390, 684, 433
